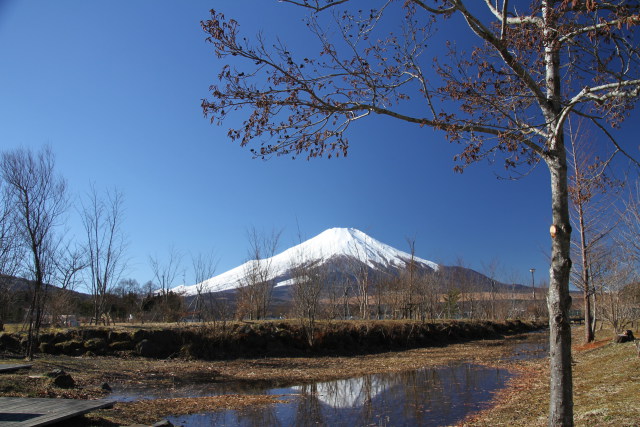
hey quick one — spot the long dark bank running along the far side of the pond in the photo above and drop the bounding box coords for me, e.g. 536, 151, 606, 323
0, 320, 544, 360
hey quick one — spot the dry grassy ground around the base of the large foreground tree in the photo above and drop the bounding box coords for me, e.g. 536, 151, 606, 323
463, 328, 640, 427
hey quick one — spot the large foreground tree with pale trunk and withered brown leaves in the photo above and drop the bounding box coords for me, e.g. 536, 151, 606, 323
202, 0, 640, 425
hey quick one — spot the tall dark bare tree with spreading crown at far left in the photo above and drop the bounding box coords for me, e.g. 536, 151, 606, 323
0, 147, 68, 359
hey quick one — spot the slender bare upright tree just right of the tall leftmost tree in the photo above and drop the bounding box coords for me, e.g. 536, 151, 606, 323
82, 186, 127, 325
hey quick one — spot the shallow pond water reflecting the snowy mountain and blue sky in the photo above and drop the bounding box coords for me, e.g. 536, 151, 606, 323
111, 334, 547, 426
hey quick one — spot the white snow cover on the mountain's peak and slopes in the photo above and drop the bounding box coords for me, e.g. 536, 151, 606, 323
172, 228, 438, 295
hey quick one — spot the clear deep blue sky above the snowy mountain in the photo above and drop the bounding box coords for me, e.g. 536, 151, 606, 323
0, 0, 640, 290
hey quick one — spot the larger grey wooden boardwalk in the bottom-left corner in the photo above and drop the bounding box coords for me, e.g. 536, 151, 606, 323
0, 397, 115, 427
